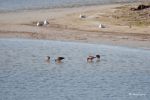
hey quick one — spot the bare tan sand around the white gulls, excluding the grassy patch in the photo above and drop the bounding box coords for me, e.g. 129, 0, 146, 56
0, 4, 150, 48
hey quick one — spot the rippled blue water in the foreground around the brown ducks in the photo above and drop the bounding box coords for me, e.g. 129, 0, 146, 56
0, 39, 150, 100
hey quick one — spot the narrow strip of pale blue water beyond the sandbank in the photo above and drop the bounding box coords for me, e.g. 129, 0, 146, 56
0, 0, 136, 11
